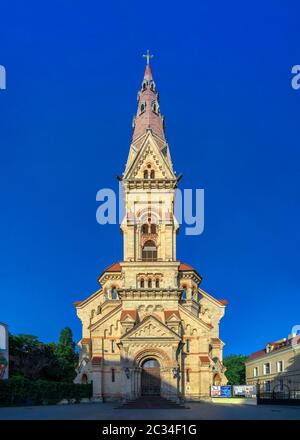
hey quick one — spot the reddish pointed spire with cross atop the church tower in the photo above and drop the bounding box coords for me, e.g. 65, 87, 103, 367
132, 50, 165, 141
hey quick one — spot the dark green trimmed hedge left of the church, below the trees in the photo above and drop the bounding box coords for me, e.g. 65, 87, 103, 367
0, 376, 92, 405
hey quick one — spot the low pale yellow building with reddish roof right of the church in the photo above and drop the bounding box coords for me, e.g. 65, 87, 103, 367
245, 334, 300, 392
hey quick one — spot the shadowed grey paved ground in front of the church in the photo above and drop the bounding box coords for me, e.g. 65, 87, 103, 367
0, 402, 300, 420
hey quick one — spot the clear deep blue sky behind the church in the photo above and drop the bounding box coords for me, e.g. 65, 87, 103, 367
0, 0, 300, 354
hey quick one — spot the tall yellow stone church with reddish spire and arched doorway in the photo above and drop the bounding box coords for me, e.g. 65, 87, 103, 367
74, 58, 227, 401
